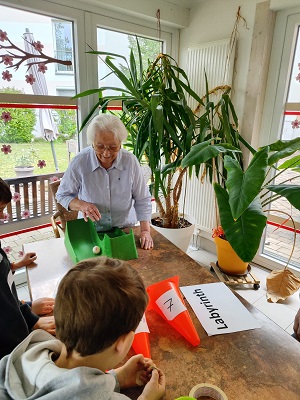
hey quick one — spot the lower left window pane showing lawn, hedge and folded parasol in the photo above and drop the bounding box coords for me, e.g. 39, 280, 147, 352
0, 105, 77, 179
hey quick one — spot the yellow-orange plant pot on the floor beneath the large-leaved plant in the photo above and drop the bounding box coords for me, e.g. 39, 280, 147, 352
214, 237, 248, 275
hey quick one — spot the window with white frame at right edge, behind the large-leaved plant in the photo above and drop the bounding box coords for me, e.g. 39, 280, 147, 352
255, 10, 300, 271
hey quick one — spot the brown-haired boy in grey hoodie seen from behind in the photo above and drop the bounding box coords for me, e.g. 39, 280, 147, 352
0, 257, 165, 400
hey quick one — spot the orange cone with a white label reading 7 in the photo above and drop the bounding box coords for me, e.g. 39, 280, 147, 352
147, 276, 200, 346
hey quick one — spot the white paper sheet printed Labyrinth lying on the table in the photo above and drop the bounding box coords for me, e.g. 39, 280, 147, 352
180, 282, 261, 336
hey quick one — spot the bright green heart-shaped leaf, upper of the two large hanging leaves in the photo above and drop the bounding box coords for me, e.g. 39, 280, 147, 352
224, 148, 268, 219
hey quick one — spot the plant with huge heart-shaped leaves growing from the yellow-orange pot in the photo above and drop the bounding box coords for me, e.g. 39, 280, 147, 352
182, 119, 300, 273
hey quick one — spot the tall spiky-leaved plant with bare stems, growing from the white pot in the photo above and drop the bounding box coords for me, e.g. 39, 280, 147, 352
75, 46, 241, 250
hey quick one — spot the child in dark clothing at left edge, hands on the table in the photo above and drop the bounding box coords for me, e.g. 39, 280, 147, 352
0, 178, 55, 358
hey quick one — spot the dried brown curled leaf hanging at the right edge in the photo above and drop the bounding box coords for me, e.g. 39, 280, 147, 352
266, 268, 300, 303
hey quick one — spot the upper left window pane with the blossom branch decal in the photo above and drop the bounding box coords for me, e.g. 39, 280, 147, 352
0, 6, 75, 96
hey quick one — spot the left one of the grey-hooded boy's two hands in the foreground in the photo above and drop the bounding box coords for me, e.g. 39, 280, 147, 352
115, 354, 154, 389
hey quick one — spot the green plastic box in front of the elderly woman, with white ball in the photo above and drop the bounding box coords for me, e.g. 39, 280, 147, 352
65, 218, 138, 264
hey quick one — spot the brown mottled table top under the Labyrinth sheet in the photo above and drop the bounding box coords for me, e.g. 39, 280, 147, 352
24, 230, 300, 400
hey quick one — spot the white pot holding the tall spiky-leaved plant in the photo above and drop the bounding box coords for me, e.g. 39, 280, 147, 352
151, 213, 196, 253
